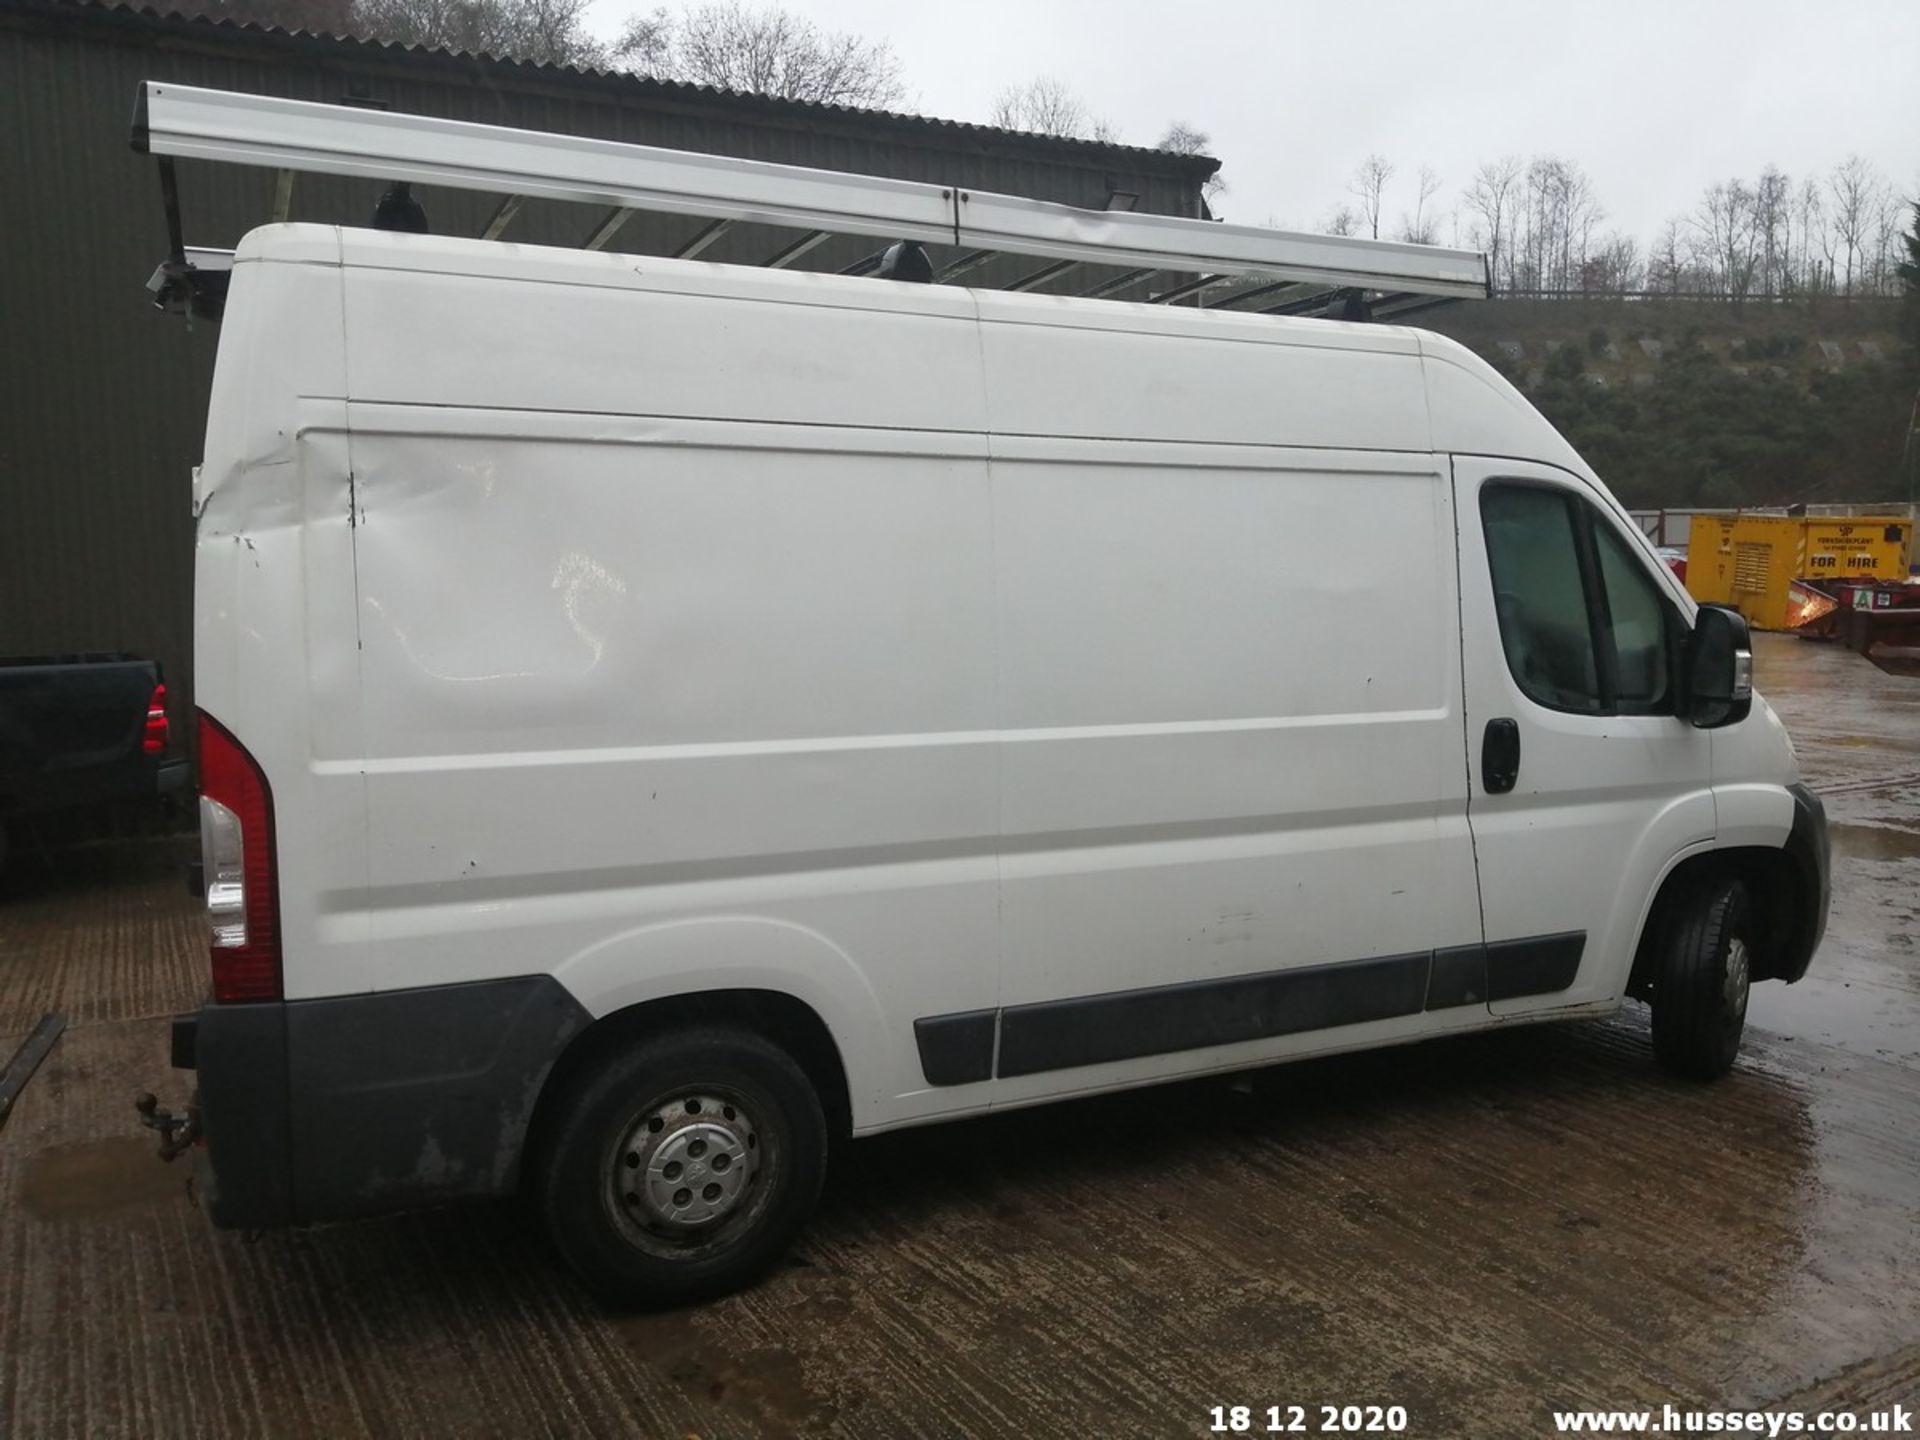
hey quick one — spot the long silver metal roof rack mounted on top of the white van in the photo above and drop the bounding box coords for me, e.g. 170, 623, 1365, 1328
132, 81, 1492, 326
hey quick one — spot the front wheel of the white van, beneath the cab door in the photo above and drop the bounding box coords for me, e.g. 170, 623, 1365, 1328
1653, 879, 1753, 1081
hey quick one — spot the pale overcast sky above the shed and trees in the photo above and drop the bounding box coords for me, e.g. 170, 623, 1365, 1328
589, 0, 1920, 244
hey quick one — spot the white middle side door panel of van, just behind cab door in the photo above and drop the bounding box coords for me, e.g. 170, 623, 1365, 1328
975, 434, 1484, 1102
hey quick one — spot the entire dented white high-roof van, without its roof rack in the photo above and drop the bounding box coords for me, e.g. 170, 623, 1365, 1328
153, 225, 1828, 1304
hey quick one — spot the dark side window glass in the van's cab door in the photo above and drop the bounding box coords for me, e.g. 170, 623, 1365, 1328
1480, 482, 1674, 714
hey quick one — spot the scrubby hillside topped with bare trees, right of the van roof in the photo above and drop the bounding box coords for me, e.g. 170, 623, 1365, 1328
1321, 156, 1920, 507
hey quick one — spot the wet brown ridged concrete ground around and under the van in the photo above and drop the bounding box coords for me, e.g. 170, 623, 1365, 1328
0, 637, 1920, 1440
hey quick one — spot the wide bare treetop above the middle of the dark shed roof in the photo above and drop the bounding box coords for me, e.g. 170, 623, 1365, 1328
618, 0, 906, 109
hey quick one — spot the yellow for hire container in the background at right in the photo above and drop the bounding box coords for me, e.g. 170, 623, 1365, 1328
1686, 515, 1914, 630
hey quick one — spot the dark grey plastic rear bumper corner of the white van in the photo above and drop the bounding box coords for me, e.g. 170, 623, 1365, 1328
173, 975, 591, 1229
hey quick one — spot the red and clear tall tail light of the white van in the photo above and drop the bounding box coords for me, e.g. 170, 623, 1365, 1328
198, 710, 280, 1000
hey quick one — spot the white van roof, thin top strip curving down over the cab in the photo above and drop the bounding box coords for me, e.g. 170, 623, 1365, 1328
234, 225, 1594, 478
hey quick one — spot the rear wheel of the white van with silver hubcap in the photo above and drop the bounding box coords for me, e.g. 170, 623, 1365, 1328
534, 1029, 828, 1309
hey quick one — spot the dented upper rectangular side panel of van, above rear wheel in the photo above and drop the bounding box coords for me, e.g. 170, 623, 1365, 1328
353, 436, 993, 756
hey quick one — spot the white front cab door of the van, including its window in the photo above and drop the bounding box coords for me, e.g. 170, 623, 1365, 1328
1453, 457, 1715, 1014
